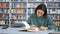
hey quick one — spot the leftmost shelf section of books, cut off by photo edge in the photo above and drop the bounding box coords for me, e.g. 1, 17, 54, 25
0, 0, 9, 25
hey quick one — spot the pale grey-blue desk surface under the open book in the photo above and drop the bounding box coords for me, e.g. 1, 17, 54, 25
0, 28, 53, 34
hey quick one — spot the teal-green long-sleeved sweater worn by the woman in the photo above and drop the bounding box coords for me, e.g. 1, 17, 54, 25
27, 13, 56, 30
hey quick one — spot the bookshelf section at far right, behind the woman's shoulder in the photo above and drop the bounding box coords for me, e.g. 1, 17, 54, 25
46, 0, 60, 26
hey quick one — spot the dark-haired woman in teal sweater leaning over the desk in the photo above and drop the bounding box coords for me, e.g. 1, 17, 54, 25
27, 4, 56, 30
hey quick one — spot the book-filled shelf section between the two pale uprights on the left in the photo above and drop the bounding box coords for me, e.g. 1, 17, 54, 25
10, 0, 27, 27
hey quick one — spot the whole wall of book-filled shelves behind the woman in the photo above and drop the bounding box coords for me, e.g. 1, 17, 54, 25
0, 0, 60, 27
